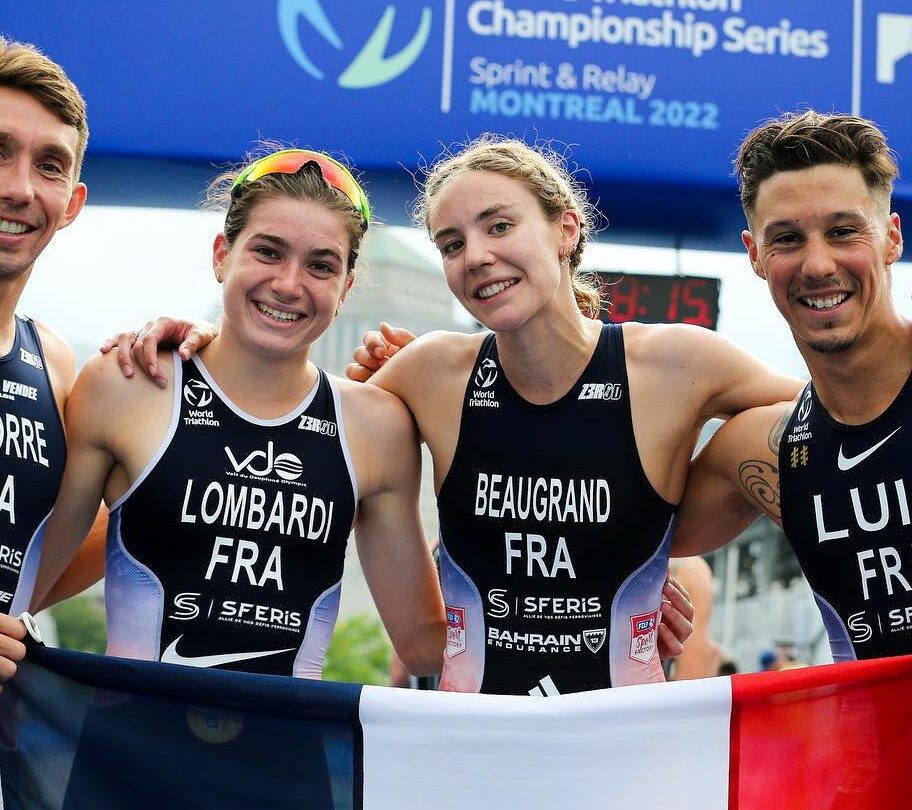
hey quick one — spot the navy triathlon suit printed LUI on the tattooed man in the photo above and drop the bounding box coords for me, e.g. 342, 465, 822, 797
779, 380, 912, 661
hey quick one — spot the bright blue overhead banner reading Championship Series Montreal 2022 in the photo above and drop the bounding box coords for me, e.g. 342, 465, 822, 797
0, 0, 912, 198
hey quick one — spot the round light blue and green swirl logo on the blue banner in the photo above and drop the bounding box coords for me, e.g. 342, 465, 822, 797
278, 0, 431, 90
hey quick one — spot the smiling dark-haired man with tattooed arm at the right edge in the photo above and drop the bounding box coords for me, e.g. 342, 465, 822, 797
672, 111, 912, 661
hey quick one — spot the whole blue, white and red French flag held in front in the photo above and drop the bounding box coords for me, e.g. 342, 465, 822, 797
0, 647, 912, 810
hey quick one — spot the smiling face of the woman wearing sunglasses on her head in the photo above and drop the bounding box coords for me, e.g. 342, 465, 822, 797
213, 196, 353, 359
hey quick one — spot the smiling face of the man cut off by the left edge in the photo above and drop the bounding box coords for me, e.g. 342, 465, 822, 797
0, 87, 86, 284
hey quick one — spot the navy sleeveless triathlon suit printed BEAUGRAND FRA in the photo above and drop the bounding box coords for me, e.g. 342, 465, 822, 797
437, 324, 674, 695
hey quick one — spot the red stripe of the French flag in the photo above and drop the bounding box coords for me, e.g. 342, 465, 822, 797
729, 656, 912, 810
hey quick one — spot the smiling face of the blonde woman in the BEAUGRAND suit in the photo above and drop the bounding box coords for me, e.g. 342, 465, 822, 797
429, 170, 579, 331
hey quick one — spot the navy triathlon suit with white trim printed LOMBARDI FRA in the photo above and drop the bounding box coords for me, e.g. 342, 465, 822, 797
17, 355, 357, 678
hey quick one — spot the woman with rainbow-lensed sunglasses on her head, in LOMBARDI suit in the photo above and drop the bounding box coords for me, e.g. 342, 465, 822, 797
8, 149, 444, 678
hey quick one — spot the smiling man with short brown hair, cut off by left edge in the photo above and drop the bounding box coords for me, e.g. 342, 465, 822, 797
0, 37, 101, 680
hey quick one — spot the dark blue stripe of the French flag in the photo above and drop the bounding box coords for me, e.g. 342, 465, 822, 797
0, 646, 363, 810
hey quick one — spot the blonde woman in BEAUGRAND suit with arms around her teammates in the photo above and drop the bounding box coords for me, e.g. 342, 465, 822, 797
112, 136, 799, 695
